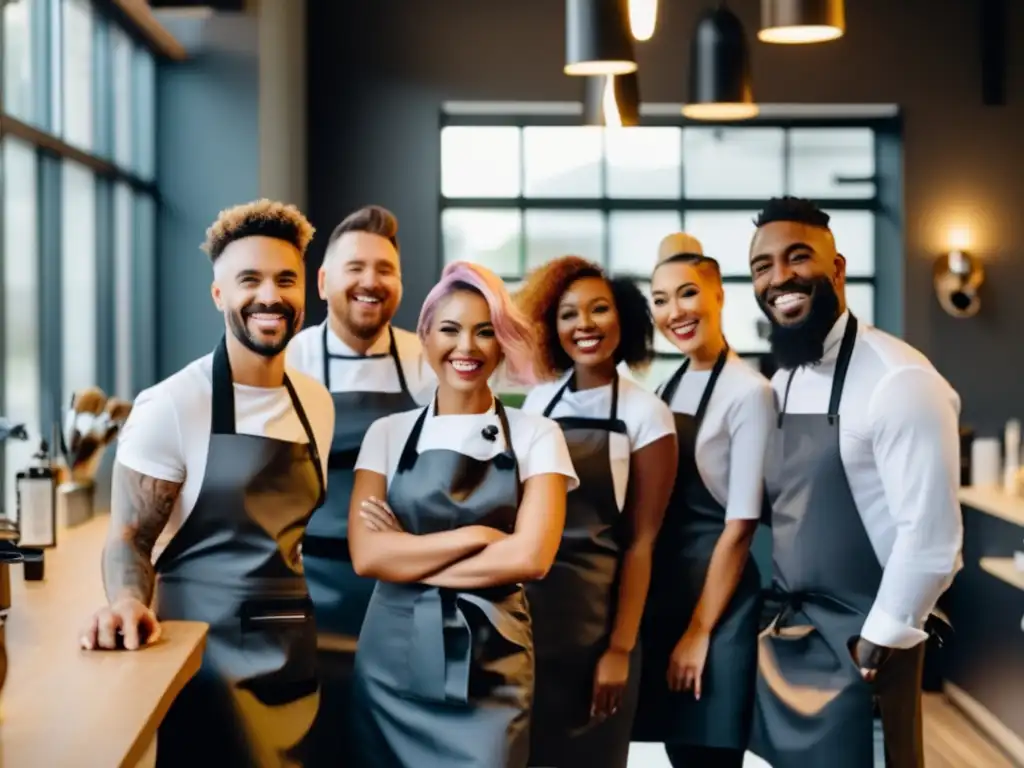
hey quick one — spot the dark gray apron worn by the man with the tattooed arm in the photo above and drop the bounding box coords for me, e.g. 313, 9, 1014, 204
154, 340, 324, 768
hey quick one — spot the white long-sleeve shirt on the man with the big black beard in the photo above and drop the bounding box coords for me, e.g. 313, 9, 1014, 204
772, 312, 964, 648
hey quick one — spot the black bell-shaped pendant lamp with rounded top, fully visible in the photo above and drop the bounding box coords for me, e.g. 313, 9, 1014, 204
683, 3, 758, 120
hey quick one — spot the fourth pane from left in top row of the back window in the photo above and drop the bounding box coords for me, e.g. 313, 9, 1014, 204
683, 128, 785, 200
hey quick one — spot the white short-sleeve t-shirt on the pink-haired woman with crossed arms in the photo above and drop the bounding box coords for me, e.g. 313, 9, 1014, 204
355, 406, 580, 490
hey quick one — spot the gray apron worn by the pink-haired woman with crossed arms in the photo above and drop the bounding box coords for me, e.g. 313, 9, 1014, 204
352, 400, 534, 768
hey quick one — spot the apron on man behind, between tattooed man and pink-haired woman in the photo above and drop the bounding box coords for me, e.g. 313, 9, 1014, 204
302, 321, 417, 768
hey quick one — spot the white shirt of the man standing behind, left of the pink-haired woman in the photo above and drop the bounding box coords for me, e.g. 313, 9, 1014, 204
287, 321, 437, 406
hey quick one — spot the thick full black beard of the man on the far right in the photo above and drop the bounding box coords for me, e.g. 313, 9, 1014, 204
757, 276, 840, 370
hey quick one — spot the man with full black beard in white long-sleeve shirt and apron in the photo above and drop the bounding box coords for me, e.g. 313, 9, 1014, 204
750, 198, 963, 768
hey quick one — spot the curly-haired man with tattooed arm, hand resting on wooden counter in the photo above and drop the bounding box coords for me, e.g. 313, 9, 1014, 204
81, 200, 334, 768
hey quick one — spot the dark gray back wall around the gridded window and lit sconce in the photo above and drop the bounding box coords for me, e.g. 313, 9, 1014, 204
307, 0, 1024, 433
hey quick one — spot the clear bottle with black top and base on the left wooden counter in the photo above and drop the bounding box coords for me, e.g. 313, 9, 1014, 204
14, 440, 57, 581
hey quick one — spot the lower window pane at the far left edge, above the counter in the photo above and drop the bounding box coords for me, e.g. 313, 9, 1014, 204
0, 138, 41, 517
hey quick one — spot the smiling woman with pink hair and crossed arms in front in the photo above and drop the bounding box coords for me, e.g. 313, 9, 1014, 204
349, 262, 579, 768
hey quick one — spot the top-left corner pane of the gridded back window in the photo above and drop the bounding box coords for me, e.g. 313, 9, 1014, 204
441, 126, 519, 198
